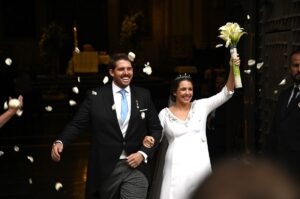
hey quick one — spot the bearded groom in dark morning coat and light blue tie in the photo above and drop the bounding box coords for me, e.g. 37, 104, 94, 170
51, 53, 162, 199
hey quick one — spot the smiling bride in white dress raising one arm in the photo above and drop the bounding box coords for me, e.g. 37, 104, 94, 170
143, 58, 240, 199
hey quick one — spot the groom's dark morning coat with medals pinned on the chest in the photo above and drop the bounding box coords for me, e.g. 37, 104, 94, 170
59, 84, 162, 199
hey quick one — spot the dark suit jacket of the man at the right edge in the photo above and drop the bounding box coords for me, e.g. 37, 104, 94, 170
266, 87, 300, 173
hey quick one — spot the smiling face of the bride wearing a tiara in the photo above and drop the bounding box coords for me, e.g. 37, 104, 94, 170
174, 80, 193, 104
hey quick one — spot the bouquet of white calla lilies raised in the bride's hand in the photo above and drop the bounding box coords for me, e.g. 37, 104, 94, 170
219, 22, 247, 88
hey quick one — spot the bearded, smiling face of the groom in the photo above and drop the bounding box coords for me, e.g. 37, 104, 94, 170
109, 60, 133, 88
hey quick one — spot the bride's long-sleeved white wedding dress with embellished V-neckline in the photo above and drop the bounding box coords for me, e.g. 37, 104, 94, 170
159, 87, 233, 199
